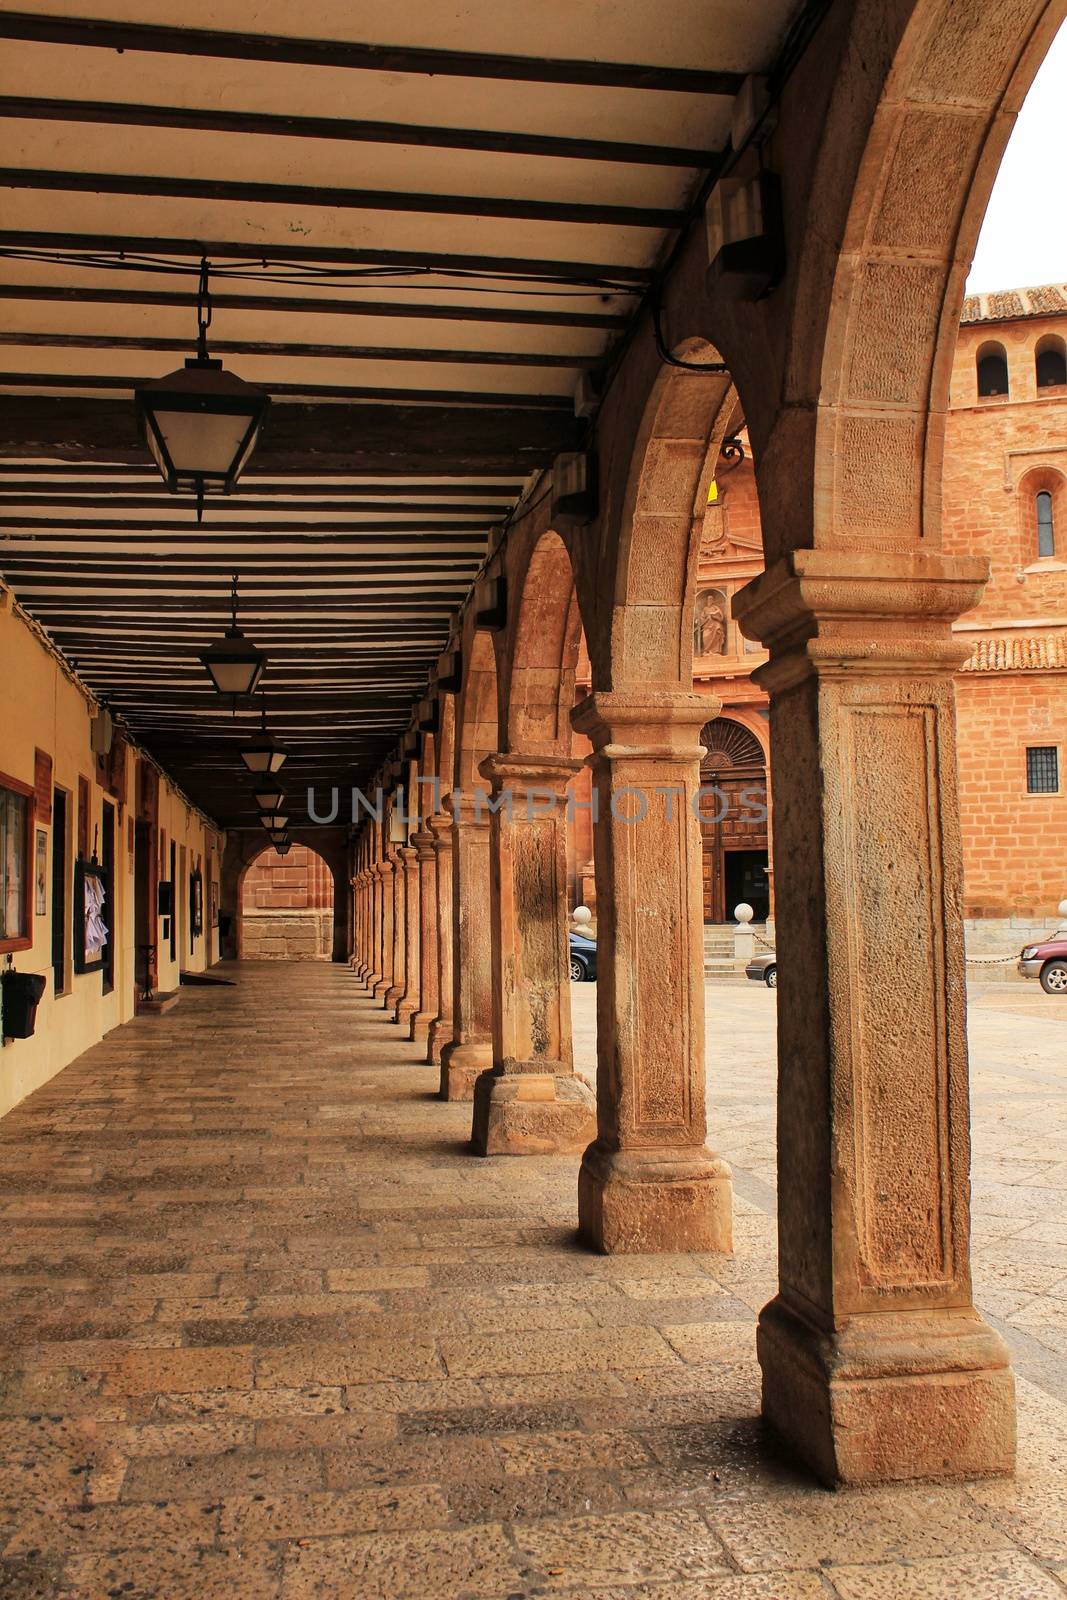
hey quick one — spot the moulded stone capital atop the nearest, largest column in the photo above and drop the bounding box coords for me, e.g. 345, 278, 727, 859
733, 550, 989, 690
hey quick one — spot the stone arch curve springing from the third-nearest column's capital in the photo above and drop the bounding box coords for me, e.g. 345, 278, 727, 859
499, 528, 582, 755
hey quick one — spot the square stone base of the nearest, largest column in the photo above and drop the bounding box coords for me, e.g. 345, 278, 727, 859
757, 1296, 1016, 1485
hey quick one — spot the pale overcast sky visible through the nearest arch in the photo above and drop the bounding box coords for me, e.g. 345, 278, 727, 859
966, 27, 1067, 294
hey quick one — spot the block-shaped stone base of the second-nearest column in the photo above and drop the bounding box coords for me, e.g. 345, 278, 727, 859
577, 1144, 733, 1256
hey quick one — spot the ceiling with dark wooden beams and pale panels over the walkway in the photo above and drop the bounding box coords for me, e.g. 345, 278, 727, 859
0, 0, 795, 826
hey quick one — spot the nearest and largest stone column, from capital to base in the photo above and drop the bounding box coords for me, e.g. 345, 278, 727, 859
734, 550, 1014, 1483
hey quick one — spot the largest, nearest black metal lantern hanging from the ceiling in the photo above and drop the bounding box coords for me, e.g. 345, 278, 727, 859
133, 258, 270, 522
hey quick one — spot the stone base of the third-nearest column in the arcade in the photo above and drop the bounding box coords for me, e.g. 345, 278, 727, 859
470, 1067, 597, 1155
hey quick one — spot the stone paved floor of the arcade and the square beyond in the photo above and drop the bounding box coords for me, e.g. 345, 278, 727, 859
0, 963, 1067, 1600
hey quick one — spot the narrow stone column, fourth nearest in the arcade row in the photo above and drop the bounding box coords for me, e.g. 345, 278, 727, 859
442, 795, 493, 1099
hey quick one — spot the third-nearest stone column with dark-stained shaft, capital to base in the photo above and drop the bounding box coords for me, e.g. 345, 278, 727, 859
470, 755, 597, 1155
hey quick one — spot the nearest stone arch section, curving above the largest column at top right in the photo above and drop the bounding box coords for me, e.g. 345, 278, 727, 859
796, 0, 1065, 557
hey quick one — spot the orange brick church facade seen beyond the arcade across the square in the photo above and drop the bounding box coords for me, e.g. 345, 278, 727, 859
681, 286, 1067, 946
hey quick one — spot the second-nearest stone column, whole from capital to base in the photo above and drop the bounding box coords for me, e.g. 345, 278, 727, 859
571, 690, 731, 1251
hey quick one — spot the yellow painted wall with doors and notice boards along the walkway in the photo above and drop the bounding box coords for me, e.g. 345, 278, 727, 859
0, 590, 221, 1115
